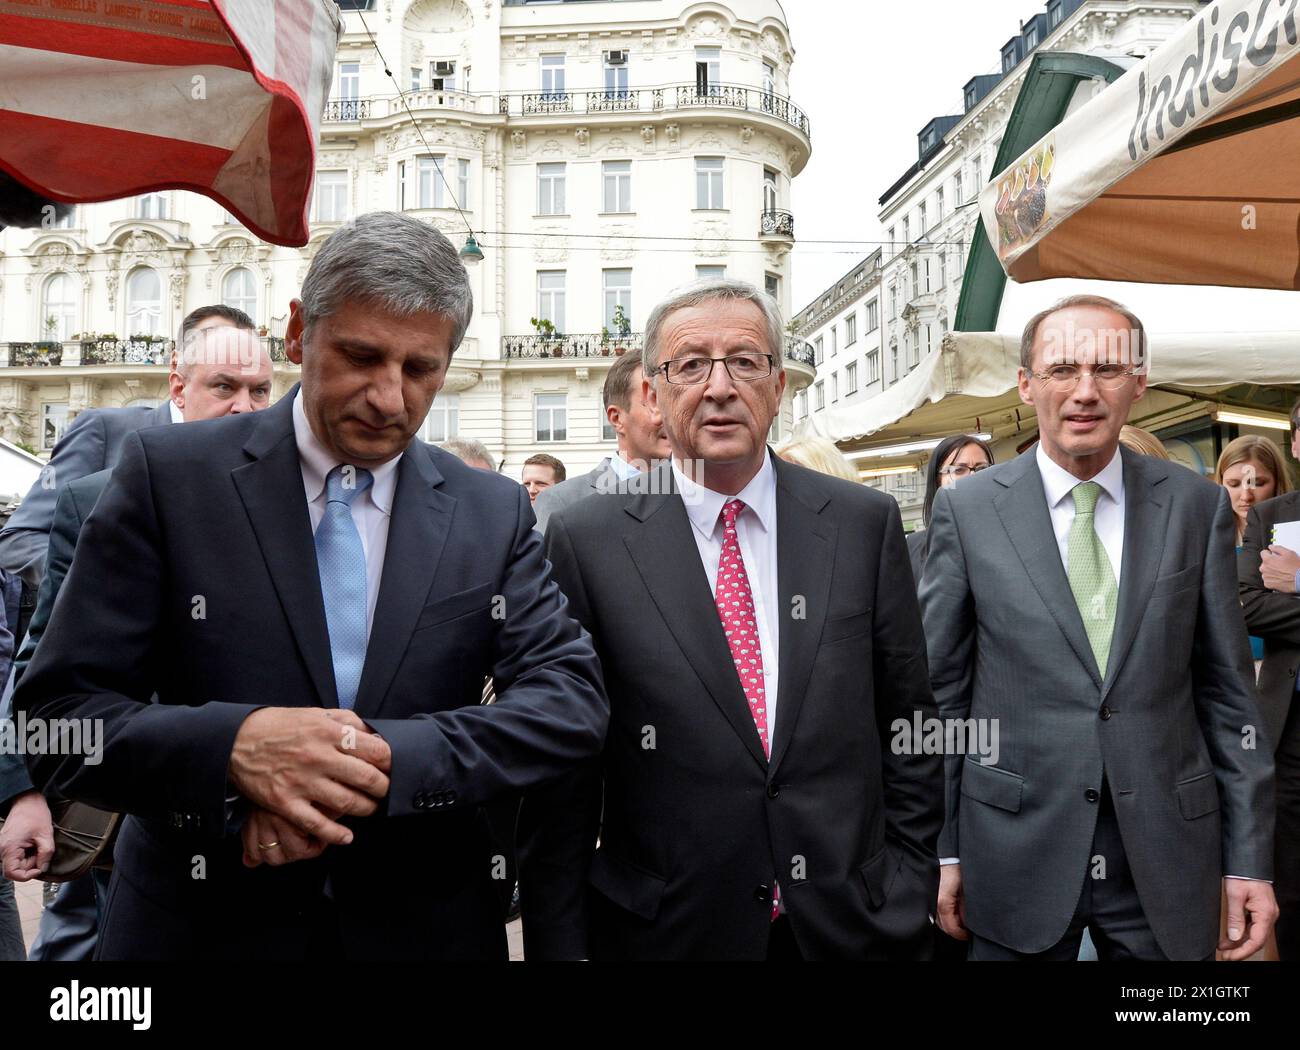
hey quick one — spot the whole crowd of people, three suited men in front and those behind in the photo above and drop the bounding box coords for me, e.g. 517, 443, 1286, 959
0, 212, 1300, 960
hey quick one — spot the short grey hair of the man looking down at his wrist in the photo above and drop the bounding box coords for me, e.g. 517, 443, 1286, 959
300, 212, 475, 351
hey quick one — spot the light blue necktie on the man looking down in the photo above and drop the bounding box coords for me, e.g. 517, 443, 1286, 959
316, 464, 374, 708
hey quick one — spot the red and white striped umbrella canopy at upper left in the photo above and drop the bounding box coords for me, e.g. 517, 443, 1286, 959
0, 0, 342, 247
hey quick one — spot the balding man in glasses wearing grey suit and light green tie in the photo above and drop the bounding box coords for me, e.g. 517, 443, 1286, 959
920, 296, 1277, 960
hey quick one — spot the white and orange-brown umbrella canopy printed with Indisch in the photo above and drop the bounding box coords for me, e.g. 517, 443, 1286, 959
980, 0, 1300, 288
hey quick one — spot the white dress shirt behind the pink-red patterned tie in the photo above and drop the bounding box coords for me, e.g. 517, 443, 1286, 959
672, 454, 781, 746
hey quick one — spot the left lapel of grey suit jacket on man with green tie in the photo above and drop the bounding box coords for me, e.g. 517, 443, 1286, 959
993, 448, 1101, 687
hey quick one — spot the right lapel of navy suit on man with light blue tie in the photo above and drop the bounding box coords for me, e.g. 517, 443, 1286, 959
356, 441, 456, 717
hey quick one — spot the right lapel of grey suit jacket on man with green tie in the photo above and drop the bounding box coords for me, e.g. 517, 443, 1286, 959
1102, 448, 1183, 695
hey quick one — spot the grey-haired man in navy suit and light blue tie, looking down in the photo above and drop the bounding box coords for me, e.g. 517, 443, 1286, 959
14, 212, 607, 960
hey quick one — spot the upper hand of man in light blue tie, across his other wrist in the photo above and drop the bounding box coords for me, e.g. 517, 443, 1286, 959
229, 707, 393, 846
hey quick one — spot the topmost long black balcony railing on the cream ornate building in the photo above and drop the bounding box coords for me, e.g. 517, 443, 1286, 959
324, 83, 813, 138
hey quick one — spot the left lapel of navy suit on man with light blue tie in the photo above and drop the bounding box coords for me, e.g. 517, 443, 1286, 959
230, 386, 338, 707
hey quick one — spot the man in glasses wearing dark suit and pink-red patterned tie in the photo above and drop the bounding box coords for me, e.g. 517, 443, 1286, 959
520, 279, 943, 959
